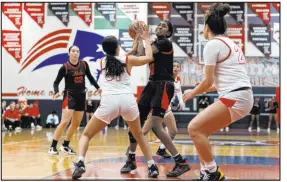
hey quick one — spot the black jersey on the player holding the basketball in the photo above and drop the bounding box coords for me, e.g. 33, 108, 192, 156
149, 39, 174, 81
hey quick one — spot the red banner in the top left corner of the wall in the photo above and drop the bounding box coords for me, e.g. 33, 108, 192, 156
1, 3, 22, 30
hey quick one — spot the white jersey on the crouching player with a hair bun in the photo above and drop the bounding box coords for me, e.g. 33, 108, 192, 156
204, 37, 251, 96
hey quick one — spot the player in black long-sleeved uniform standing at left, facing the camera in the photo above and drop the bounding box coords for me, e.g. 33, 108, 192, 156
48, 45, 101, 155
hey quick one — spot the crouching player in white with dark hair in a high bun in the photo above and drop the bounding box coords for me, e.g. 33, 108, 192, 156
183, 3, 253, 181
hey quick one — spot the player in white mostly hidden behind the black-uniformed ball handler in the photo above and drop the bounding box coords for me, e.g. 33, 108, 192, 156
142, 61, 184, 158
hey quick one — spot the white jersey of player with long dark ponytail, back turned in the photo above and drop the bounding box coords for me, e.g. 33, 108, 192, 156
98, 56, 133, 95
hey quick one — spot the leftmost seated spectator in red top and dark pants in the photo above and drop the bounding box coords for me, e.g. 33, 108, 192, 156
3, 101, 21, 131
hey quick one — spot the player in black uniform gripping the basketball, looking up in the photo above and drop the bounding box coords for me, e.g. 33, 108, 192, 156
121, 20, 190, 177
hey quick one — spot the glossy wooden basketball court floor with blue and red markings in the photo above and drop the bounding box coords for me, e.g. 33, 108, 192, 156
1, 128, 280, 180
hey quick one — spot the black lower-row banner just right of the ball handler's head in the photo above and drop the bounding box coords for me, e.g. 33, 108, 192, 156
173, 25, 194, 55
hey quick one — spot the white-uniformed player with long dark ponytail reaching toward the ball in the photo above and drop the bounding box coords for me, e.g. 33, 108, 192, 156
72, 25, 159, 179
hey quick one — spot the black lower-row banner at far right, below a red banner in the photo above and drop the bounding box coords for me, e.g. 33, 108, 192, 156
249, 24, 271, 56
